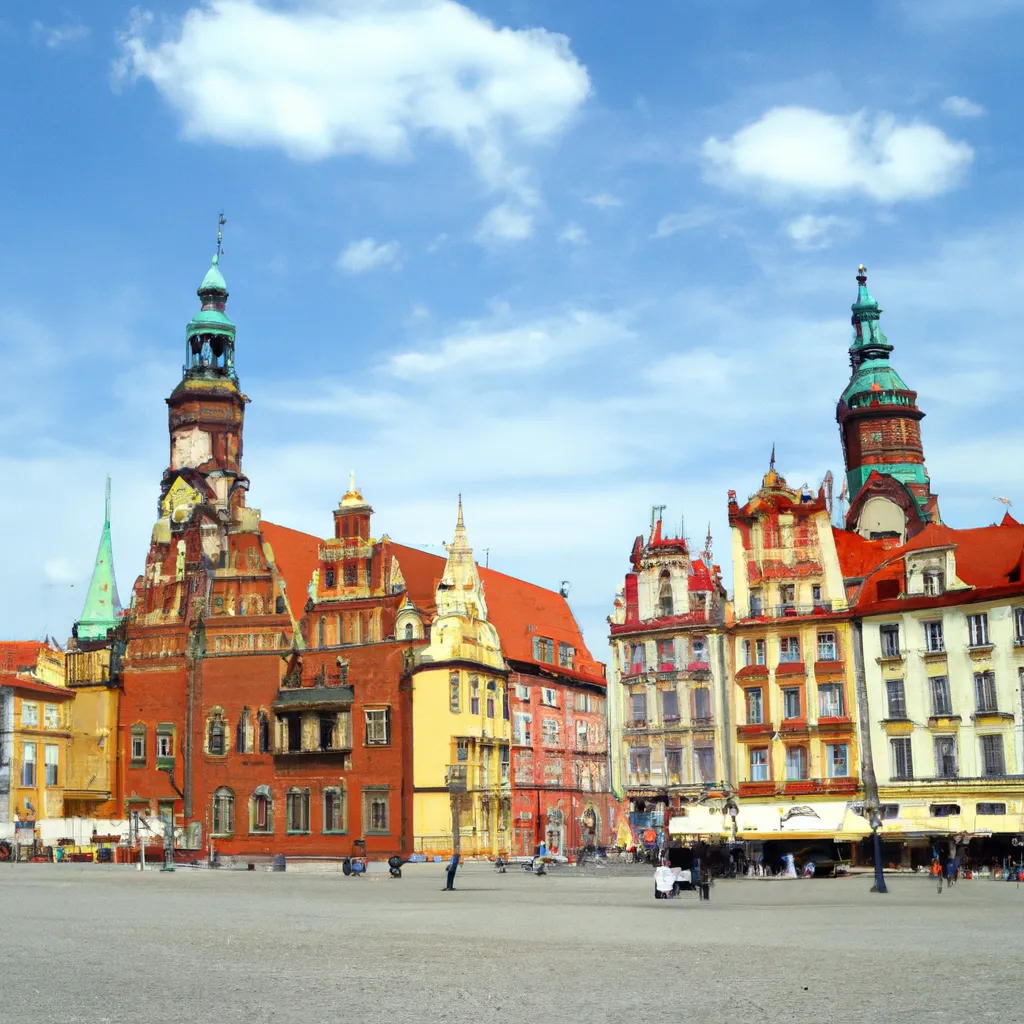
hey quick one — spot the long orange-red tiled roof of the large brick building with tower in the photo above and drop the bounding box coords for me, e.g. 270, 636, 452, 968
260, 520, 604, 684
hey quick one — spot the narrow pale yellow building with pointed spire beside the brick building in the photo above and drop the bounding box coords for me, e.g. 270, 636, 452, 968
412, 499, 511, 856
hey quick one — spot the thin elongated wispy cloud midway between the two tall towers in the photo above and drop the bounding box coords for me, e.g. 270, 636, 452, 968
386, 309, 632, 378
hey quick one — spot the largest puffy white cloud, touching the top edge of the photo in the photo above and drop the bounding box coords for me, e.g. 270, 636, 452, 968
115, 0, 590, 193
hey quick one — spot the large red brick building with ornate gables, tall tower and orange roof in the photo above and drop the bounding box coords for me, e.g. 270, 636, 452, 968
118, 249, 613, 857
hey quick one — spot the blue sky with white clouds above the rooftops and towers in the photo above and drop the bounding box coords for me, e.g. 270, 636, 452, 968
0, 0, 1024, 656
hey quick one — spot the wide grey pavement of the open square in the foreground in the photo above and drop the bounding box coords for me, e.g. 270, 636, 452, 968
0, 864, 1024, 1024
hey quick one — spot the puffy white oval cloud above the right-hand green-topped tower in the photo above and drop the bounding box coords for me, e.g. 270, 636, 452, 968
702, 106, 974, 203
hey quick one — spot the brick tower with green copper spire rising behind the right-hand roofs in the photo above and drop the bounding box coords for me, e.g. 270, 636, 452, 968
836, 264, 939, 542
